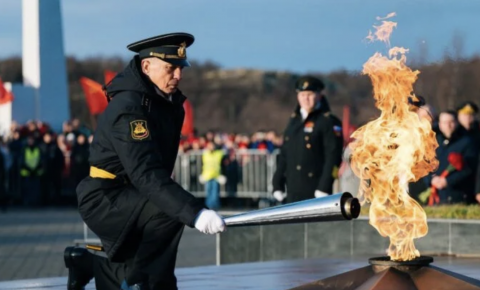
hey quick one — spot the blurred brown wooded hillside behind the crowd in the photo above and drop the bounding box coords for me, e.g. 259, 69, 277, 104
0, 57, 480, 133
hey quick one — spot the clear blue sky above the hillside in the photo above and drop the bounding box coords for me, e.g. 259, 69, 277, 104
0, 0, 480, 73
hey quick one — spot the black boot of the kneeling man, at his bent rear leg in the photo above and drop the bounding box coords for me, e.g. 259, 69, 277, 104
63, 247, 93, 290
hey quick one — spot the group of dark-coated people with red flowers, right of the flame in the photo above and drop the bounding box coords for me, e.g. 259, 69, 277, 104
410, 101, 480, 205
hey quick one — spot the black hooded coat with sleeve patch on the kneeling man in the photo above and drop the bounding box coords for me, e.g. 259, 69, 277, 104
77, 57, 203, 261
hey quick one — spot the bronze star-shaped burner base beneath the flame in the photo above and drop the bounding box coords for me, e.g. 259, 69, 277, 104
290, 256, 480, 290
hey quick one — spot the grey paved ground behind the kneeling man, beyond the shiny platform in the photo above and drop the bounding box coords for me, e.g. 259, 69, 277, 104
0, 208, 215, 281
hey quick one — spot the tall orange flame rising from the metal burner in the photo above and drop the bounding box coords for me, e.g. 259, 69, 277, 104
350, 14, 438, 261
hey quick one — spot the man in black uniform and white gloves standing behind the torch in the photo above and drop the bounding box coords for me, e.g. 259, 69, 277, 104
273, 76, 343, 203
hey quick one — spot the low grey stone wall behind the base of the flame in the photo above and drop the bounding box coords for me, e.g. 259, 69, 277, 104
217, 218, 480, 264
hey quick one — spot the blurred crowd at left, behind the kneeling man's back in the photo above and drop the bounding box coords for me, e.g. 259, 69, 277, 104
0, 119, 92, 207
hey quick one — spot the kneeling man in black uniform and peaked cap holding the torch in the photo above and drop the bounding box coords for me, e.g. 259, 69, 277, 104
65, 33, 225, 290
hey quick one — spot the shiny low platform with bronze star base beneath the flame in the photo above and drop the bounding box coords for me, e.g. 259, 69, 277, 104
0, 257, 480, 290
